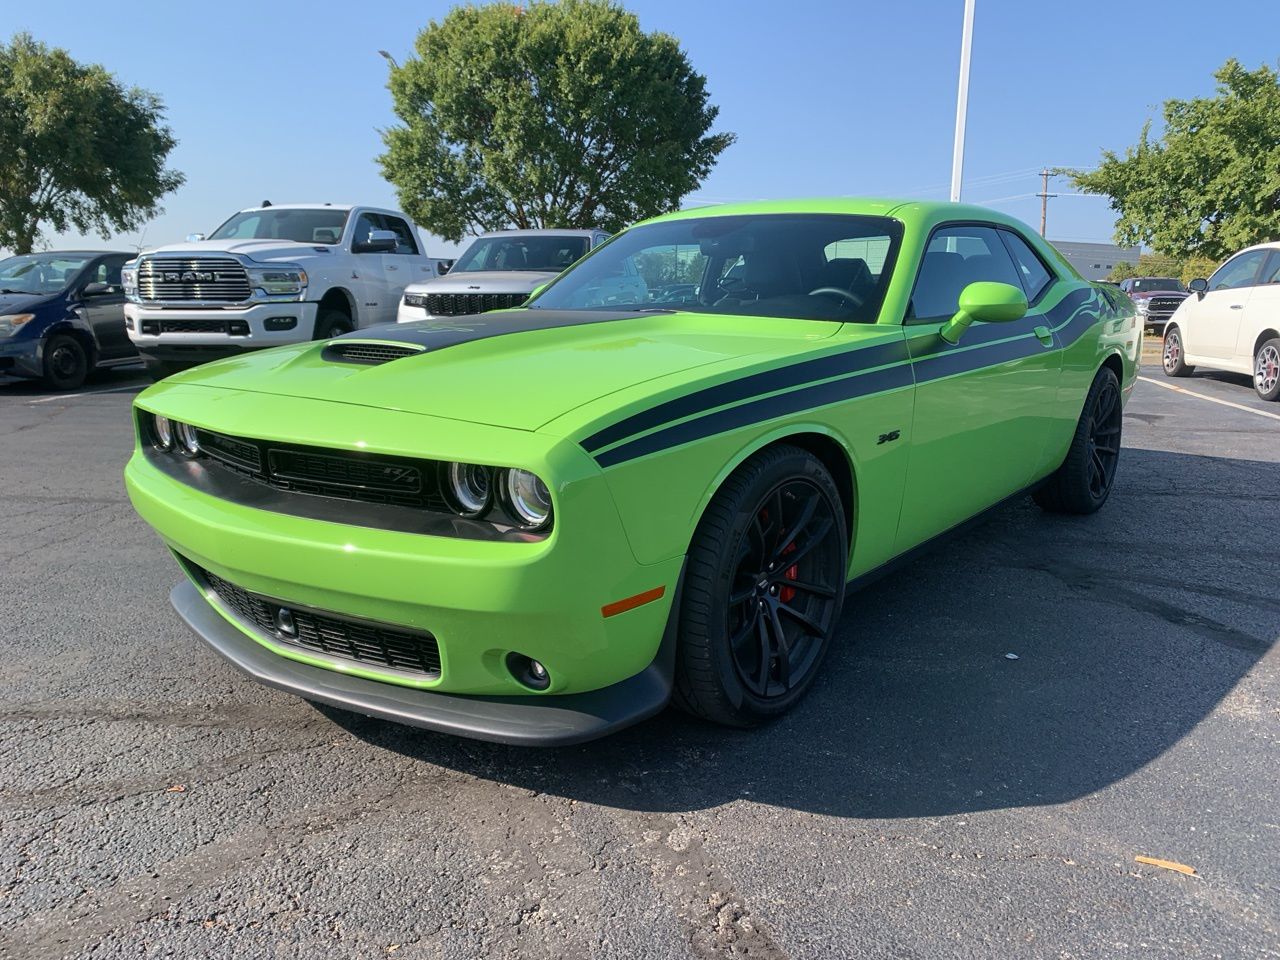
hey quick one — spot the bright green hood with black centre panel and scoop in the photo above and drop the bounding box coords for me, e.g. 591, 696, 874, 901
169, 310, 840, 430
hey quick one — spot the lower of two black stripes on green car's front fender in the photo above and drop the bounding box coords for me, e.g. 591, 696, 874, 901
595, 364, 913, 467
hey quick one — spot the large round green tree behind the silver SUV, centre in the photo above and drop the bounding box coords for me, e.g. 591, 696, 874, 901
380, 0, 733, 241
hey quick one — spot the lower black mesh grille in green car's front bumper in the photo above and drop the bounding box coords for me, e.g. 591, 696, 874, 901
186, 561, 440, 677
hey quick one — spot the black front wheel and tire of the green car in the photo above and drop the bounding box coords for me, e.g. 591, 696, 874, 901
673, 445, 849, 727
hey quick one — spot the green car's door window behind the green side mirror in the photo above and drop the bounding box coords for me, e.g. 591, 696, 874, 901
908, 225, 1021, 320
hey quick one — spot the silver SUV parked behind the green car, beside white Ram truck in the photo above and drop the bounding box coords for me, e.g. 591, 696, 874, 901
396, 230, 609, 324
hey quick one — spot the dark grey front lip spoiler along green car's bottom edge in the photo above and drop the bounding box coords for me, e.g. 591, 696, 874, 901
169, 581, 676, 746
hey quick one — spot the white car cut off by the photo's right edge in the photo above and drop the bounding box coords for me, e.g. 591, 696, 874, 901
1164, 242, 1280, 399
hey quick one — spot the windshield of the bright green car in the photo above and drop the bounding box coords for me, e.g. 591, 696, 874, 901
531, 214, 902, 323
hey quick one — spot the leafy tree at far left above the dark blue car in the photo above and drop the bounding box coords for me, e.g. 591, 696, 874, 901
0, 33, 183, 253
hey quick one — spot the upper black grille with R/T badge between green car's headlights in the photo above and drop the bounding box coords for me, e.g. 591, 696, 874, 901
196, 430, 448, 511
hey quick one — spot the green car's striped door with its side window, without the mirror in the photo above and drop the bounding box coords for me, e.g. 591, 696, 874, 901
896, 224, 1062, 553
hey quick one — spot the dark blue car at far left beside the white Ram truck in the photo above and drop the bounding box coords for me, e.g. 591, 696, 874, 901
0, 256, 138, 390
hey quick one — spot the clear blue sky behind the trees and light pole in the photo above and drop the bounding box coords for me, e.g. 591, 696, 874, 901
4, 0, 1280, 256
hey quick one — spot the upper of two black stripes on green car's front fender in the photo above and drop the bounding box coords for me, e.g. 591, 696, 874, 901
581, 340, 908, 453
